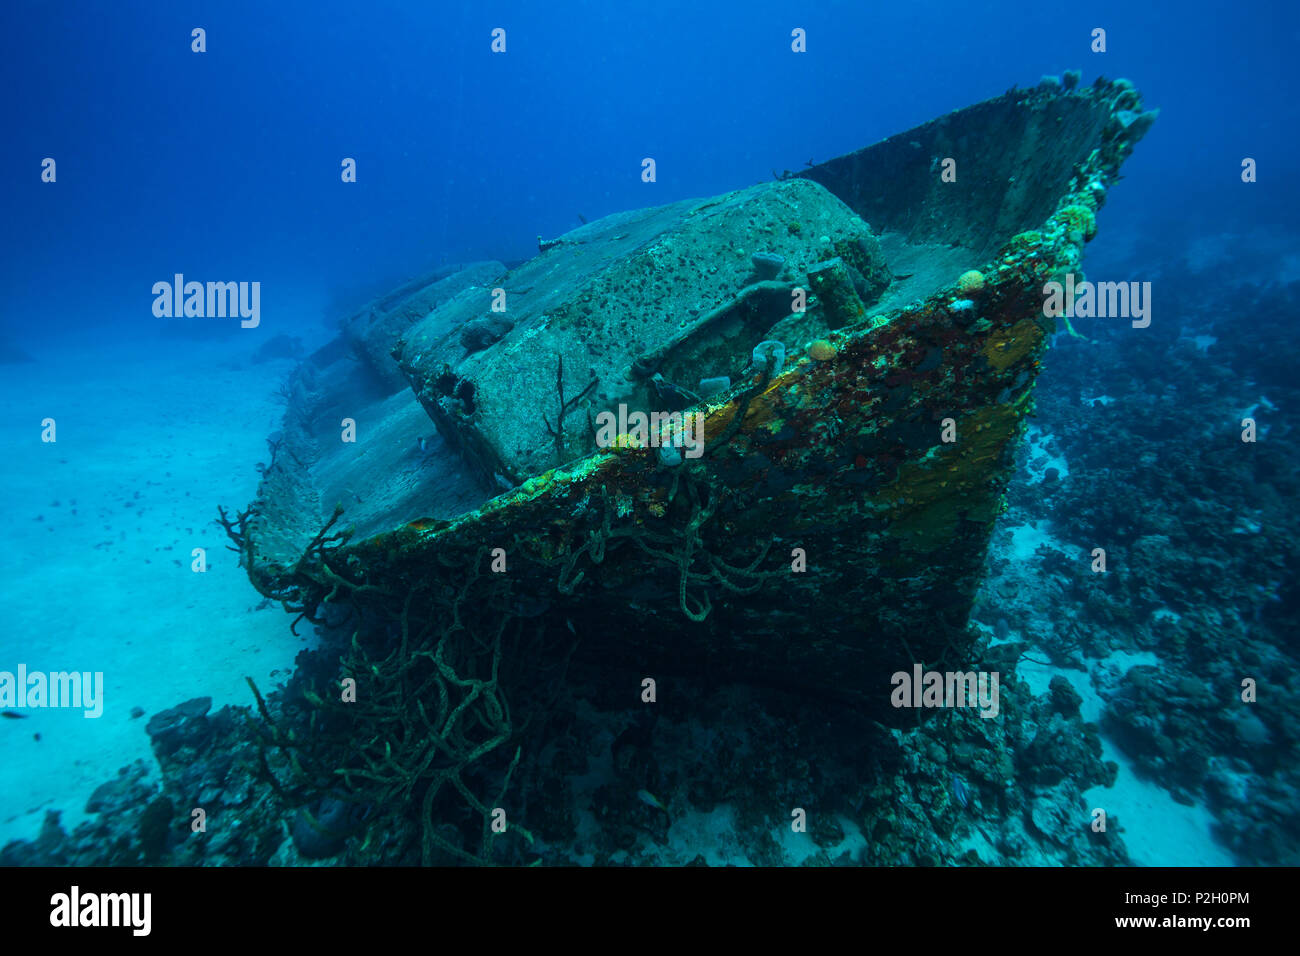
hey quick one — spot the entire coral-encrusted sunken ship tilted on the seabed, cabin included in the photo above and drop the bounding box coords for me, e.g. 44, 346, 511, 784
228, 81, 1153, 718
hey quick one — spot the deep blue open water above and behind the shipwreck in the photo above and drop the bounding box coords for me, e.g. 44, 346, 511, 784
0, 0, 1300, 343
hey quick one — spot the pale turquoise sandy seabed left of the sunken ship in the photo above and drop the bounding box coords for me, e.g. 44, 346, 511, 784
0, 336, 303, 844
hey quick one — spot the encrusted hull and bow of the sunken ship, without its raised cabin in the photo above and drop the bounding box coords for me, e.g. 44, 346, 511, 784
231, 82, 1149, 717
